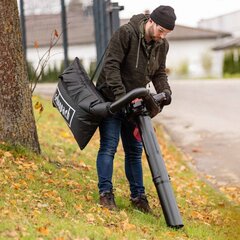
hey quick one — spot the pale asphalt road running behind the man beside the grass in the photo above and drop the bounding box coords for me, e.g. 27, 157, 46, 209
35, 79, 240, 186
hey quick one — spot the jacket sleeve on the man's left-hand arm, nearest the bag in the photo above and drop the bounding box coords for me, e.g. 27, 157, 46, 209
101, 25, 130, 100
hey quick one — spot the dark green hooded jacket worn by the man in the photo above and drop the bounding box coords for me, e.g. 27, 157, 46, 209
96, 14, 171, 101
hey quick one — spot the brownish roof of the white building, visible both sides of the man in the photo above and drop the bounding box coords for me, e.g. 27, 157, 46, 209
25, 11, 231, 47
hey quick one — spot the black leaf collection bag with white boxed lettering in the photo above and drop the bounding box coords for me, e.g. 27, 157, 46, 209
52, 57, 109, 150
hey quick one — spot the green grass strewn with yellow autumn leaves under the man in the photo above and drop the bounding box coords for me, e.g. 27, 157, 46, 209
0, 97, 240, 240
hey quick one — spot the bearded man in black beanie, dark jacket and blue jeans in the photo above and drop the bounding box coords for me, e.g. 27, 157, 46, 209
96, 6, 176, 213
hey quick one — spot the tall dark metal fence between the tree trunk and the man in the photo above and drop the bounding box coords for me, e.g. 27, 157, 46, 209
19, 0, 123, 75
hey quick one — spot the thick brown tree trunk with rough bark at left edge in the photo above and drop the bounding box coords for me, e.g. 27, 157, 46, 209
0, 0, 40, 153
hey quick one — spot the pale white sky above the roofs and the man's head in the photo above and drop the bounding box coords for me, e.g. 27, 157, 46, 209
112, 0, 240, 27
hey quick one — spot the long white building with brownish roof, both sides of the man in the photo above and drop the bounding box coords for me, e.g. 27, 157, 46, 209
26, 4, 231, 78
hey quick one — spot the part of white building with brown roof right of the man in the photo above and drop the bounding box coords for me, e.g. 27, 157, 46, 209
167, 25, 231, 78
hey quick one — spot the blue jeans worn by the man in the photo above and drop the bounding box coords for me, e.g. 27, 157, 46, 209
97, 113, 145, 198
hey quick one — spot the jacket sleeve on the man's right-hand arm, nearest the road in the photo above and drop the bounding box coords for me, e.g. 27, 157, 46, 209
152, 41, 172, 95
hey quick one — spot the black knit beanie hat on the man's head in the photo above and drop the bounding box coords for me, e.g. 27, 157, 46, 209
150, 5, 177, 30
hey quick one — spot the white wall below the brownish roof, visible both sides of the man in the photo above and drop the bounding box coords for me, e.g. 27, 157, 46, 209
27, 40, 223, 78
